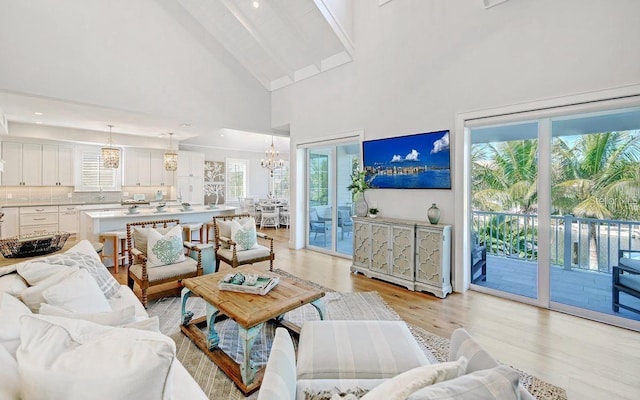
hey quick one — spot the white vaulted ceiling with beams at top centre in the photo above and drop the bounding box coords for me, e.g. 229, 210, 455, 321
172, 0, 353, 90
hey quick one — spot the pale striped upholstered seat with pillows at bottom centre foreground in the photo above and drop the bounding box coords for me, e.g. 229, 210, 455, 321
258, 321, 534, 400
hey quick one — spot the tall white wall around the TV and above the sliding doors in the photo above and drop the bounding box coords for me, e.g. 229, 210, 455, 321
271, 0, 640, 268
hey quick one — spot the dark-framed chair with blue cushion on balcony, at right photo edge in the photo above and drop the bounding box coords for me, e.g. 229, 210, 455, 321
611, 250, 640, 313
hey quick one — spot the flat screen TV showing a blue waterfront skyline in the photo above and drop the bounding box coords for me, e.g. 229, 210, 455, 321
362, 130, 451, 189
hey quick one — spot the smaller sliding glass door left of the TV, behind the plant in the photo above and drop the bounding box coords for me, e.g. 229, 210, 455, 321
307, 143, 360, 256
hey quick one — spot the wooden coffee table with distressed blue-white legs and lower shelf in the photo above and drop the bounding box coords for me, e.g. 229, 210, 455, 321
180, 266, 325, 395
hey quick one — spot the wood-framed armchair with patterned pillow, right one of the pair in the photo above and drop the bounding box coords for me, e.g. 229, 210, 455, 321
208, 214, 275, 271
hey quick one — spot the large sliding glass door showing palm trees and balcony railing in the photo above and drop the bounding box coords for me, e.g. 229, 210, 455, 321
467, 103, 640, 329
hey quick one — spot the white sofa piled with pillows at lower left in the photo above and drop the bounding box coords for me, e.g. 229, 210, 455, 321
0, 241, 207, 400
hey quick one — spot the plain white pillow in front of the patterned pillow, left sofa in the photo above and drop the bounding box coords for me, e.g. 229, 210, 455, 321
42, 269, 111, 313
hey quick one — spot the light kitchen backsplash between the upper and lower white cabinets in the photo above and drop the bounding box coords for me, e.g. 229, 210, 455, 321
0, 186, 175, 206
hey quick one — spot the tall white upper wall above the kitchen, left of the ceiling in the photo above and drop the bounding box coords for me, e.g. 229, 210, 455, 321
0, 0, 270, 131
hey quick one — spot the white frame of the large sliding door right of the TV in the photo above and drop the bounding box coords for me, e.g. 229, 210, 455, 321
453, 85, 640, 330
